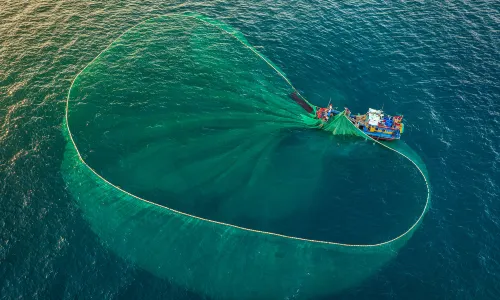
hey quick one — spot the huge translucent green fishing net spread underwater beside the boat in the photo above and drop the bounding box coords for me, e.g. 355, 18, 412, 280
62, 14, 429, 299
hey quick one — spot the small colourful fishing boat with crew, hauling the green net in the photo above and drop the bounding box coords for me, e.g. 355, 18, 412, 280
316, 106, 404, 141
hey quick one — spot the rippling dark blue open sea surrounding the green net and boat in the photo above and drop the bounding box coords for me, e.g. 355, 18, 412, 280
0, 1, 500, 299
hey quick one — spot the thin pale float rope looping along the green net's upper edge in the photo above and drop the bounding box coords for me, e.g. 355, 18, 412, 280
65, 14, 430, 247
